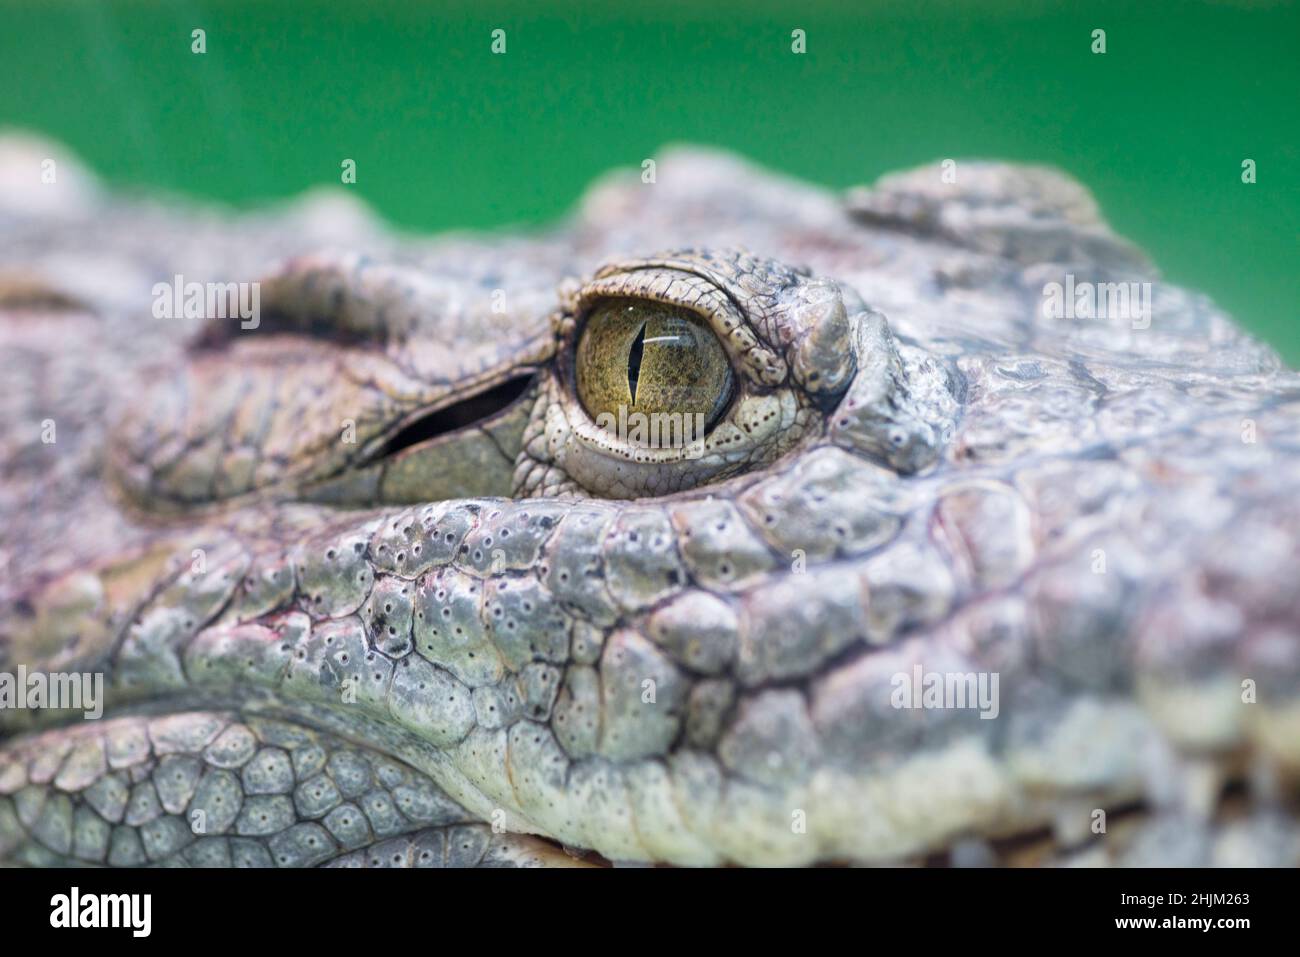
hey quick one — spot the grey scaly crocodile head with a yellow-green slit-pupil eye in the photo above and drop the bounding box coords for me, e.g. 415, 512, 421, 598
0, 135, 1300, 867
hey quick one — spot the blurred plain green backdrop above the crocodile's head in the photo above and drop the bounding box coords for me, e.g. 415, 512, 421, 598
0, 0, 1300, 365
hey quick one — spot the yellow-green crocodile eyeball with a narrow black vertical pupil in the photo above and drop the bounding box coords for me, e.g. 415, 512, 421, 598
576, 299, 732, 429
